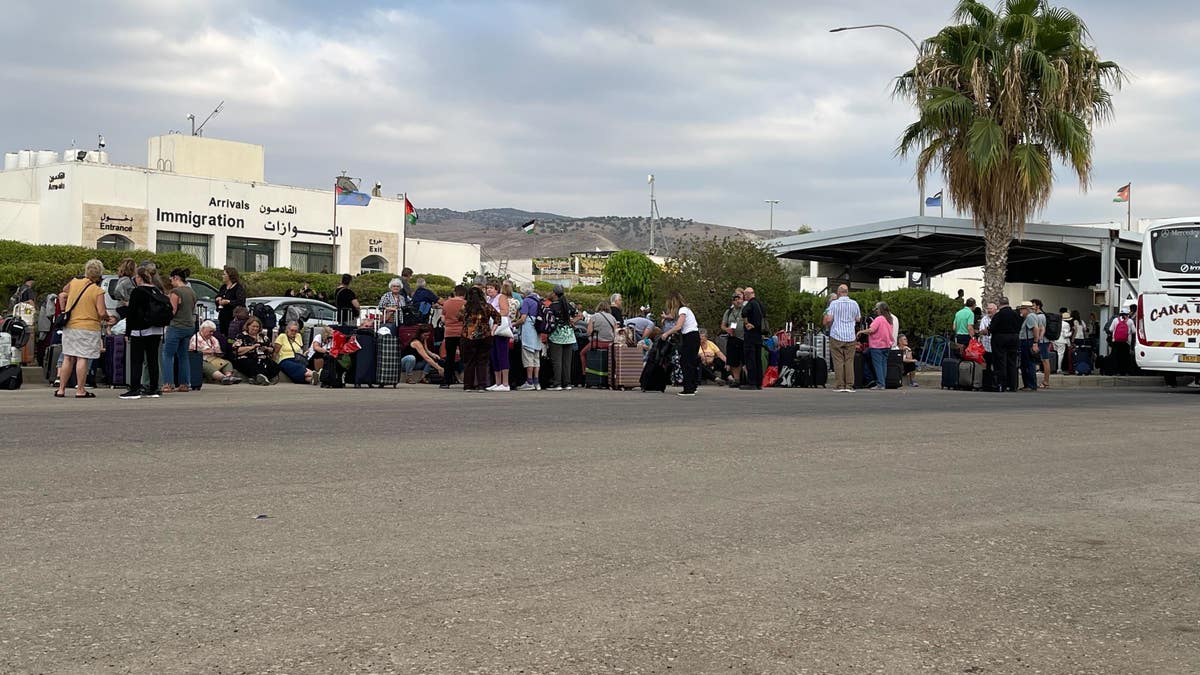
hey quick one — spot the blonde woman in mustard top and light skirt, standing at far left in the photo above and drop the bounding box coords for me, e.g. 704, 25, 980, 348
54, 259, 115, 399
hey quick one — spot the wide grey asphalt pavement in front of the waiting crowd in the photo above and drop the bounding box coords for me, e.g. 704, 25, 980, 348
0, 384, 1200, 674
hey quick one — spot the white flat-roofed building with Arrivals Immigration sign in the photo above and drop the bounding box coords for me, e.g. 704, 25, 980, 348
0, 133, 479, 276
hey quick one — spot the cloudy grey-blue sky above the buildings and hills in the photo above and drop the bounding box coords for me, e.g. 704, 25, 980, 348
0, 0, 1200, 228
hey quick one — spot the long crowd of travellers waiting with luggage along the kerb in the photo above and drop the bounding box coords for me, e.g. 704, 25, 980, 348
18, 258, 1176, 399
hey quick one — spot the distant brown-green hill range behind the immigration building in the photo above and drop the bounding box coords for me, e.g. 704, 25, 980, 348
408, 209, 784, 259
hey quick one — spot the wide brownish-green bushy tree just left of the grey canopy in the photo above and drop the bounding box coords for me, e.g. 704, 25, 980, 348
658, 238, 792, 333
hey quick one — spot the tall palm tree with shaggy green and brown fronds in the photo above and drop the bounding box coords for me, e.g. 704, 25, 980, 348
895, 0, 1126, 301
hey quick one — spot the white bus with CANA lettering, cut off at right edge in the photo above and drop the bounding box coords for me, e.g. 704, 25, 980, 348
1134, 217, 1200, 376
